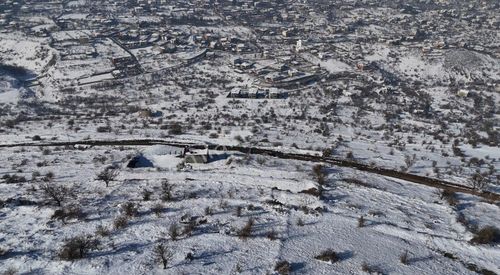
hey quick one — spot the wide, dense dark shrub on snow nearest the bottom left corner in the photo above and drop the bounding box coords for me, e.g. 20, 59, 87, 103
59, 236, 99, 261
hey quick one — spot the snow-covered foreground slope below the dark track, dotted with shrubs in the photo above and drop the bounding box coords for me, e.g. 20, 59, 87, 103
0, 146, 500, 274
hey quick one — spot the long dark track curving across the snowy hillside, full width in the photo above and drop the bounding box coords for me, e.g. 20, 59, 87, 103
0, 139, 500, 202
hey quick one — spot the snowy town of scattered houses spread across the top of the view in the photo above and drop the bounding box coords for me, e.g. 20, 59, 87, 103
0, 0, 500, 98
